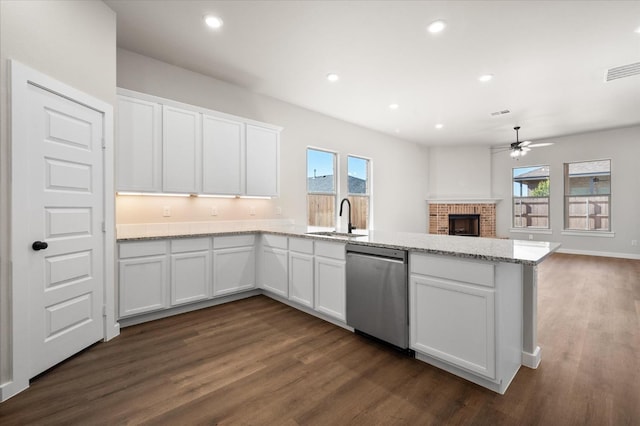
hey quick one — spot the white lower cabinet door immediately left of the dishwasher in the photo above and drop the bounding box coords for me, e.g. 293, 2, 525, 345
314, 256, 346, 321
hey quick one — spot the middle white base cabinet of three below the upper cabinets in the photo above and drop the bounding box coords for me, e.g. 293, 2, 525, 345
171, 238, 211, 305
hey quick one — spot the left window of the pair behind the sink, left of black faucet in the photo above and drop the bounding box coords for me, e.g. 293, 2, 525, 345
307, 148, 336, 227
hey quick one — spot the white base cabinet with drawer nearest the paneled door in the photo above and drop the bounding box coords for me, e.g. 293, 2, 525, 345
118, 240, 169, 317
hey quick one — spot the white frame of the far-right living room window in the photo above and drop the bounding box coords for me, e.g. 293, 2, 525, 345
563, 158, 613, 235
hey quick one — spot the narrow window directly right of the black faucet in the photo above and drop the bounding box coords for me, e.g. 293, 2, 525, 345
347, 156, 371, 229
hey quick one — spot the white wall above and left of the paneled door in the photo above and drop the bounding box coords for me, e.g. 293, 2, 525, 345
0, 0, 116, 396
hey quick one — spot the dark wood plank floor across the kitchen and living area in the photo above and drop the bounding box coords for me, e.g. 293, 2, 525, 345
0, 254, 640, 426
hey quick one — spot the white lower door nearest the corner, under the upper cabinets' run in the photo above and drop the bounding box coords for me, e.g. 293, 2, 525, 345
213, 246, 256, 296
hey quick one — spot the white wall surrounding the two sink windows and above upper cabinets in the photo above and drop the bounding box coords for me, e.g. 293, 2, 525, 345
117, 49, 428, 232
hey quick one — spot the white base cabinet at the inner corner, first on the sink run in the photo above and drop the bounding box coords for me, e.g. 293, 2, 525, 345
260, 234, 289, 298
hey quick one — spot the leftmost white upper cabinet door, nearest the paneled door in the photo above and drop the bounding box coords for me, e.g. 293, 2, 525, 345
116, 96, 162, 192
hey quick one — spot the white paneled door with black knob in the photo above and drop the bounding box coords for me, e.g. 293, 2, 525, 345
25, 80, 104, 377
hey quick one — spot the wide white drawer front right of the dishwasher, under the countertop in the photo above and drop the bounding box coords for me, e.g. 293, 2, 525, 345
409, 253, 495, 287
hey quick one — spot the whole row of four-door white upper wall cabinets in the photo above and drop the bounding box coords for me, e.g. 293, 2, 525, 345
116, 89, 281, 197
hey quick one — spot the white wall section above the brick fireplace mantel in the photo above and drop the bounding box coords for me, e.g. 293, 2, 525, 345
429, 146, 491, 199
